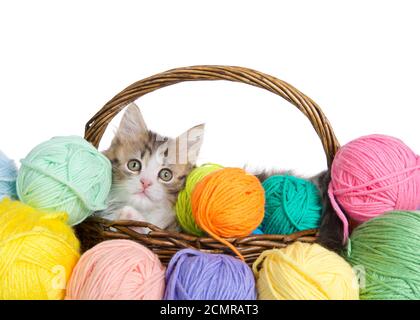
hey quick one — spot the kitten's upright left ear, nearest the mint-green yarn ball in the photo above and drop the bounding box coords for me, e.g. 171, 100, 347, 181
116, 102, 148, 137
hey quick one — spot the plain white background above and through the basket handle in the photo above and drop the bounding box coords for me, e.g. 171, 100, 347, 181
0, 0, 420, 174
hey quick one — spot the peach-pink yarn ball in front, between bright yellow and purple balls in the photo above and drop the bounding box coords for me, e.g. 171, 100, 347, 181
66, 240, 165, 300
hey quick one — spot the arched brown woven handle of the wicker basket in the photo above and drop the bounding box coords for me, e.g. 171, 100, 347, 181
85, 66, 339, 167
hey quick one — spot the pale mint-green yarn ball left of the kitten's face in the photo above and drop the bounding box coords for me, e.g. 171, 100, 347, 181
17, 136, 112, 226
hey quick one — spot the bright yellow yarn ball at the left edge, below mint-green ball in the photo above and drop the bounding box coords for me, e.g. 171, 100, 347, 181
0, 198, 79, 300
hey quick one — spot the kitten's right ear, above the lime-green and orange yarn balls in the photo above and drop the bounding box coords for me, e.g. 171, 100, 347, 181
177, 124, 205, 164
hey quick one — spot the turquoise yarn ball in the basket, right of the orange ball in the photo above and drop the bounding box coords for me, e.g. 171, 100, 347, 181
260, 175, 322, 234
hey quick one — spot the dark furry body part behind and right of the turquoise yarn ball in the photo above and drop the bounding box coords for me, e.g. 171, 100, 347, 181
256, 170, 344, 252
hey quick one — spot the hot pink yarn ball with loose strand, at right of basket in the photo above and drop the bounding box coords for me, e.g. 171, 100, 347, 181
329, 134, 420, 240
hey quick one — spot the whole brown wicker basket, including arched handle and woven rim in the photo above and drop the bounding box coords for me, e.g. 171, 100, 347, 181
76, 66, 339, 264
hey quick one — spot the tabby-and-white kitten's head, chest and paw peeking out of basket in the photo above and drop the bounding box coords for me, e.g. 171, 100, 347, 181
97, 103, 204, 233
